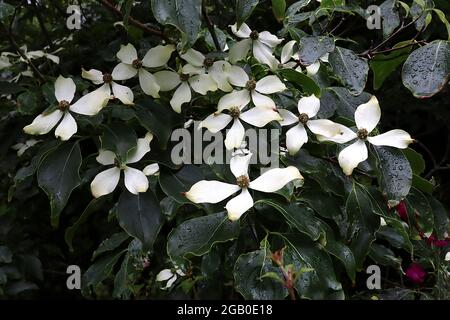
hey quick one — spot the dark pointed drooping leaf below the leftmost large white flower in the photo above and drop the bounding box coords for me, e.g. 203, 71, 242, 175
37, 143, 82, 227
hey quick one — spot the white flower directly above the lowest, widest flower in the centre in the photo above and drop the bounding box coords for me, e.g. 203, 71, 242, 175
198, 105, 281, 150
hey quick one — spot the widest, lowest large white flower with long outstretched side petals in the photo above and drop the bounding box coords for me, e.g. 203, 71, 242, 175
185, 153, 303, 221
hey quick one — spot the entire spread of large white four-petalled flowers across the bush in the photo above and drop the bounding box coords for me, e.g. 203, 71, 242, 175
24, 23, 413, 220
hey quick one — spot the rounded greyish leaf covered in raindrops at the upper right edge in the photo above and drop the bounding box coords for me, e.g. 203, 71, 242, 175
402, 40, 450, 98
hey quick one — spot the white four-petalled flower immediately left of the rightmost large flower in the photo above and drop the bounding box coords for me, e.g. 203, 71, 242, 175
278, 95, 339, 155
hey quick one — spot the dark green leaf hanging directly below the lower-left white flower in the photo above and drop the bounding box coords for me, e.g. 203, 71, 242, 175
117, 190, 164, 250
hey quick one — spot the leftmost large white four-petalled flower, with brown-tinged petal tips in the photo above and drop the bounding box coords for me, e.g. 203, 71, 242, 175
23, 76, 109, 140
